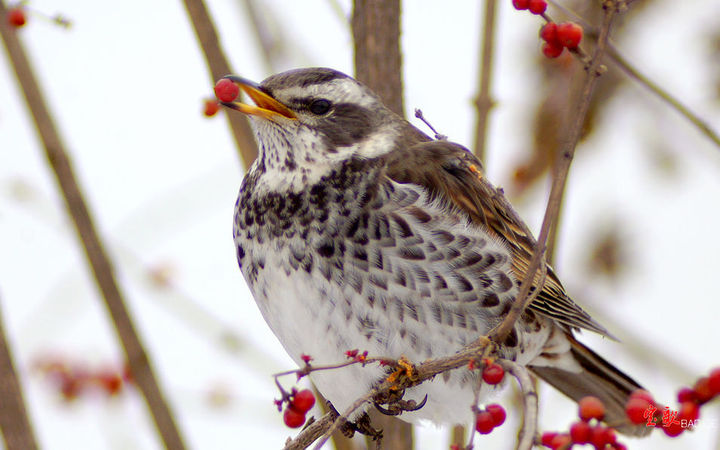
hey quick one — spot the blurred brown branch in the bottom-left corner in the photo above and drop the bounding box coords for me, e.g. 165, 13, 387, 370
0, 296, 37, 450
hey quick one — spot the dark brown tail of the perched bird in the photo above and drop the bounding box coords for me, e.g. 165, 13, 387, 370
529, 334, 652, 436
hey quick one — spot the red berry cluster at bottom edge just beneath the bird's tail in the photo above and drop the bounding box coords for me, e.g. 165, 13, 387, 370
541, 396, 627, 450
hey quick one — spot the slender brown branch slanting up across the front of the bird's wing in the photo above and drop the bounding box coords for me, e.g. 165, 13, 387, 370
491, 0, 618, 342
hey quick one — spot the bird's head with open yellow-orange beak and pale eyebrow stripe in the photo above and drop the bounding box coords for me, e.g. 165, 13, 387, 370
217, 68, 422, 190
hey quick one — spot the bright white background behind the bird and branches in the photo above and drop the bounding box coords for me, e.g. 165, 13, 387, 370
0, 0, 720, 449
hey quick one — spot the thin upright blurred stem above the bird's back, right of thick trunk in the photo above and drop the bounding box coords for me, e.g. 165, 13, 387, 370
472, 0, 497, 164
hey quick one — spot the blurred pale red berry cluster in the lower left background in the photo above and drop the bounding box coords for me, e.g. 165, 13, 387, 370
35, 358, 133, 402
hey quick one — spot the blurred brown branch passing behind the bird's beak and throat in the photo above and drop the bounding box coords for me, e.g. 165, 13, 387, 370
183, 0, 257, 167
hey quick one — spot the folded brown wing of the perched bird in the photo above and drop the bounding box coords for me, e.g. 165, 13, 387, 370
385, 141, 610, 336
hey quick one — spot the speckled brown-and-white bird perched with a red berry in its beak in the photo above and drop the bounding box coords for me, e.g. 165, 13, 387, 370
222, 67, 649, 435
